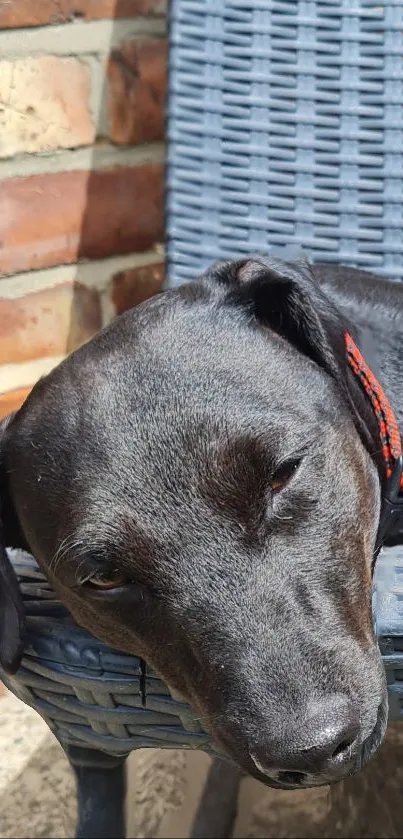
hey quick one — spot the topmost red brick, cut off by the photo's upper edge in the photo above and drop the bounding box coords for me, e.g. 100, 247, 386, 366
0, 0, 165, 29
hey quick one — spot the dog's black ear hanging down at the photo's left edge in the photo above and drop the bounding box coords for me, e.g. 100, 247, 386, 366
0, 417, 25, 673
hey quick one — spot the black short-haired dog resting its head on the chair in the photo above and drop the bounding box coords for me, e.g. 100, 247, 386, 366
0, 258, 403, 787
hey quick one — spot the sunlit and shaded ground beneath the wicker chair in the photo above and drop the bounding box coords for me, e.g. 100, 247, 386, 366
0, 696, 403, 839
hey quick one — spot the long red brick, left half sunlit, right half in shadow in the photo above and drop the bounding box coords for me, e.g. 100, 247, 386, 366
0, 164, 164, 274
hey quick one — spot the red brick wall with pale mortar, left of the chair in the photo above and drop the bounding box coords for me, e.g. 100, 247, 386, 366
0, 0, 166, 417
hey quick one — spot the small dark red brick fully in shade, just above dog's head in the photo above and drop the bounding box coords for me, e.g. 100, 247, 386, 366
111, 263, 164, 315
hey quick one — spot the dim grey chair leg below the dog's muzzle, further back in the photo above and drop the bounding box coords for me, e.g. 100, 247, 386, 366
191, 758, 242, 839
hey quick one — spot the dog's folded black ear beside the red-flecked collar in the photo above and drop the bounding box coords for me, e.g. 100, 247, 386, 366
211, 257, 383, 460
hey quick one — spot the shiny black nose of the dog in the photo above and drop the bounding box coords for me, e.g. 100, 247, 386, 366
250, 697, 360, 786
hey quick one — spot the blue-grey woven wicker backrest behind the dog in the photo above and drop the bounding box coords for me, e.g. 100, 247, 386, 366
167, 0, 403, 284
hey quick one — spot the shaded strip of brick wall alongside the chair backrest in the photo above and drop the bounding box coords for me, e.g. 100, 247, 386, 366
71, 0, 167, 351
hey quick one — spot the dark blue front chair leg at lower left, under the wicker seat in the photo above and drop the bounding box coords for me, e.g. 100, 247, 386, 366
65, 746, 126, 839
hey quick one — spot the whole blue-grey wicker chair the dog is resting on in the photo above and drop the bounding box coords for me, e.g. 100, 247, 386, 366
2, 0, 403, 837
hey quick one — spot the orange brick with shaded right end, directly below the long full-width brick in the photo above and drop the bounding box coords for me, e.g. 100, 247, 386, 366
0, 283, 101, 364
